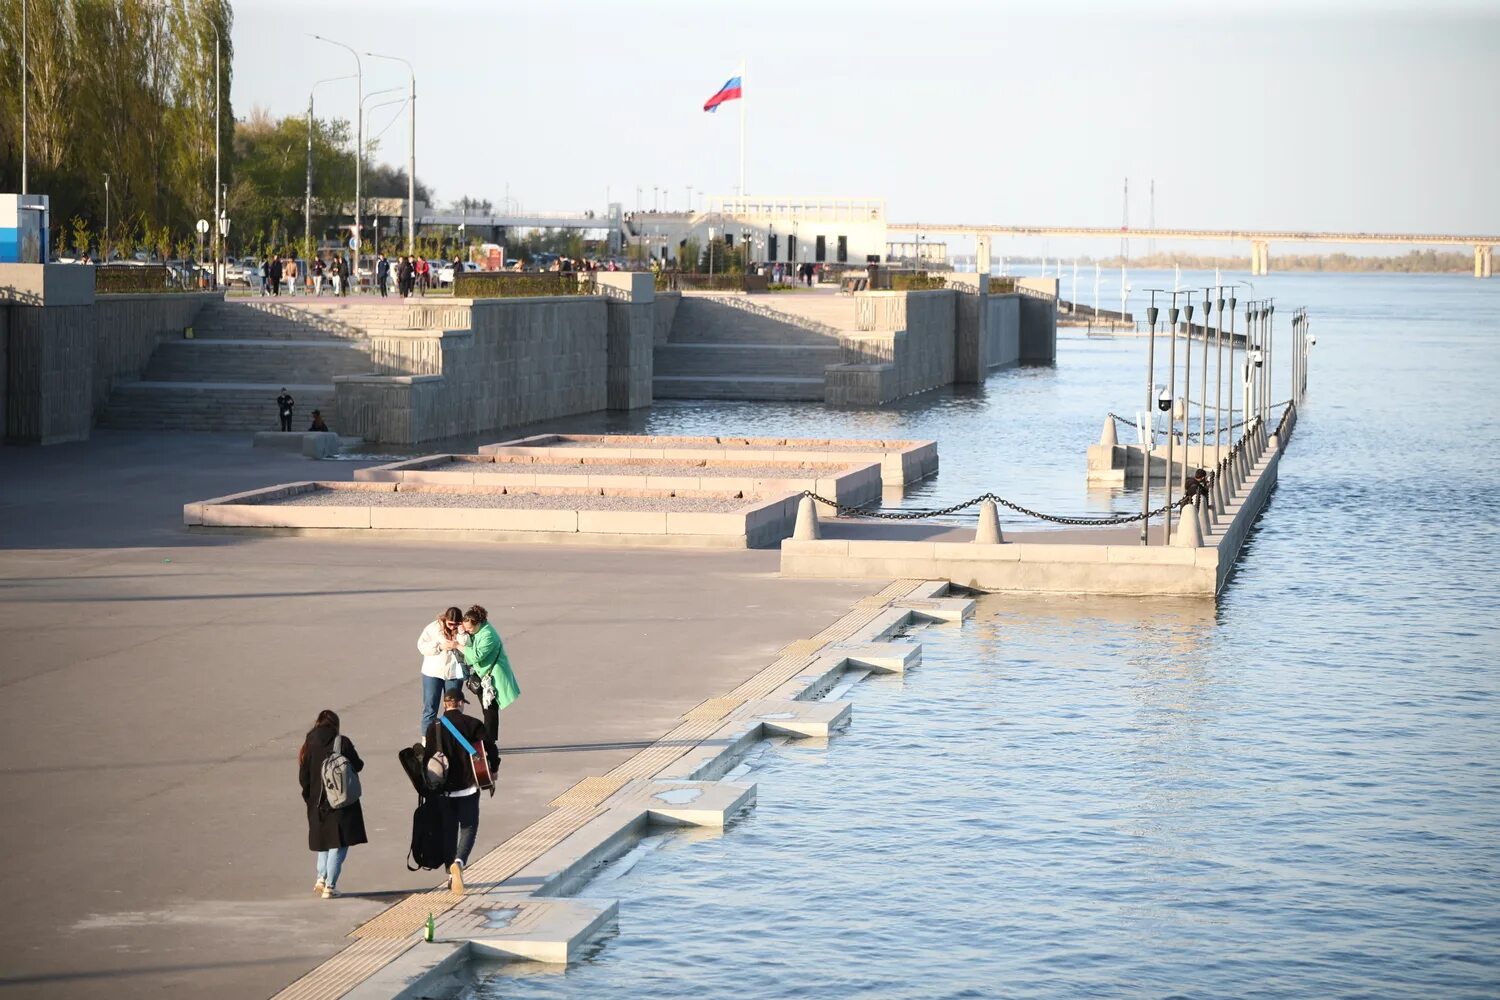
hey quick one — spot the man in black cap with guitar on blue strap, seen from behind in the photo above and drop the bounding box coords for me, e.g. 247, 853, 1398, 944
420, 688, 495, 894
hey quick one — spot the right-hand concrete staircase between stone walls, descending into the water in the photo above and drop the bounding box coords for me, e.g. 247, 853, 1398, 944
653, 292, 854, 400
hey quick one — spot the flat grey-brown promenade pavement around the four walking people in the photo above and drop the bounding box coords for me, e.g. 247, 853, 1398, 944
0, 430, 882, 1000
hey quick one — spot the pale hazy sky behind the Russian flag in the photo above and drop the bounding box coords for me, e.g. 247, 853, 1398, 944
234, 0, 1500, 239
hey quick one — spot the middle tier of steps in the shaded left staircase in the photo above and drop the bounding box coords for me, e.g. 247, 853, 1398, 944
141, 337, 374, 385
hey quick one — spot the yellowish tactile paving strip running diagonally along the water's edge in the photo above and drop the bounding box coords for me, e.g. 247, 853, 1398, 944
273, 580, 924, 1000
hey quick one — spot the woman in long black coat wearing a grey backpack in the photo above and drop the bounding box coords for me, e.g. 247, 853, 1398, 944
297, 708, 368, 900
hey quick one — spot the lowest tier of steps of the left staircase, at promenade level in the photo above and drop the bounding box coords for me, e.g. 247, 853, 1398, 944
99, 381, 335, 430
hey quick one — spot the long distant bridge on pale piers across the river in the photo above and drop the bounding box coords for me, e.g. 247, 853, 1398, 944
885, 222, 1500, 277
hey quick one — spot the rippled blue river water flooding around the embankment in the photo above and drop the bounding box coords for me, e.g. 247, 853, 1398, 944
462, 274, 1500, 1000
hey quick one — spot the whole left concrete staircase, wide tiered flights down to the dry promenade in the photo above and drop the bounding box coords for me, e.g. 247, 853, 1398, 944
99, 297, 411, 430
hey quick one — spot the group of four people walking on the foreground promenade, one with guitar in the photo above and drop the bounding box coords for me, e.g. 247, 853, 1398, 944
297, 604, 521, 900
